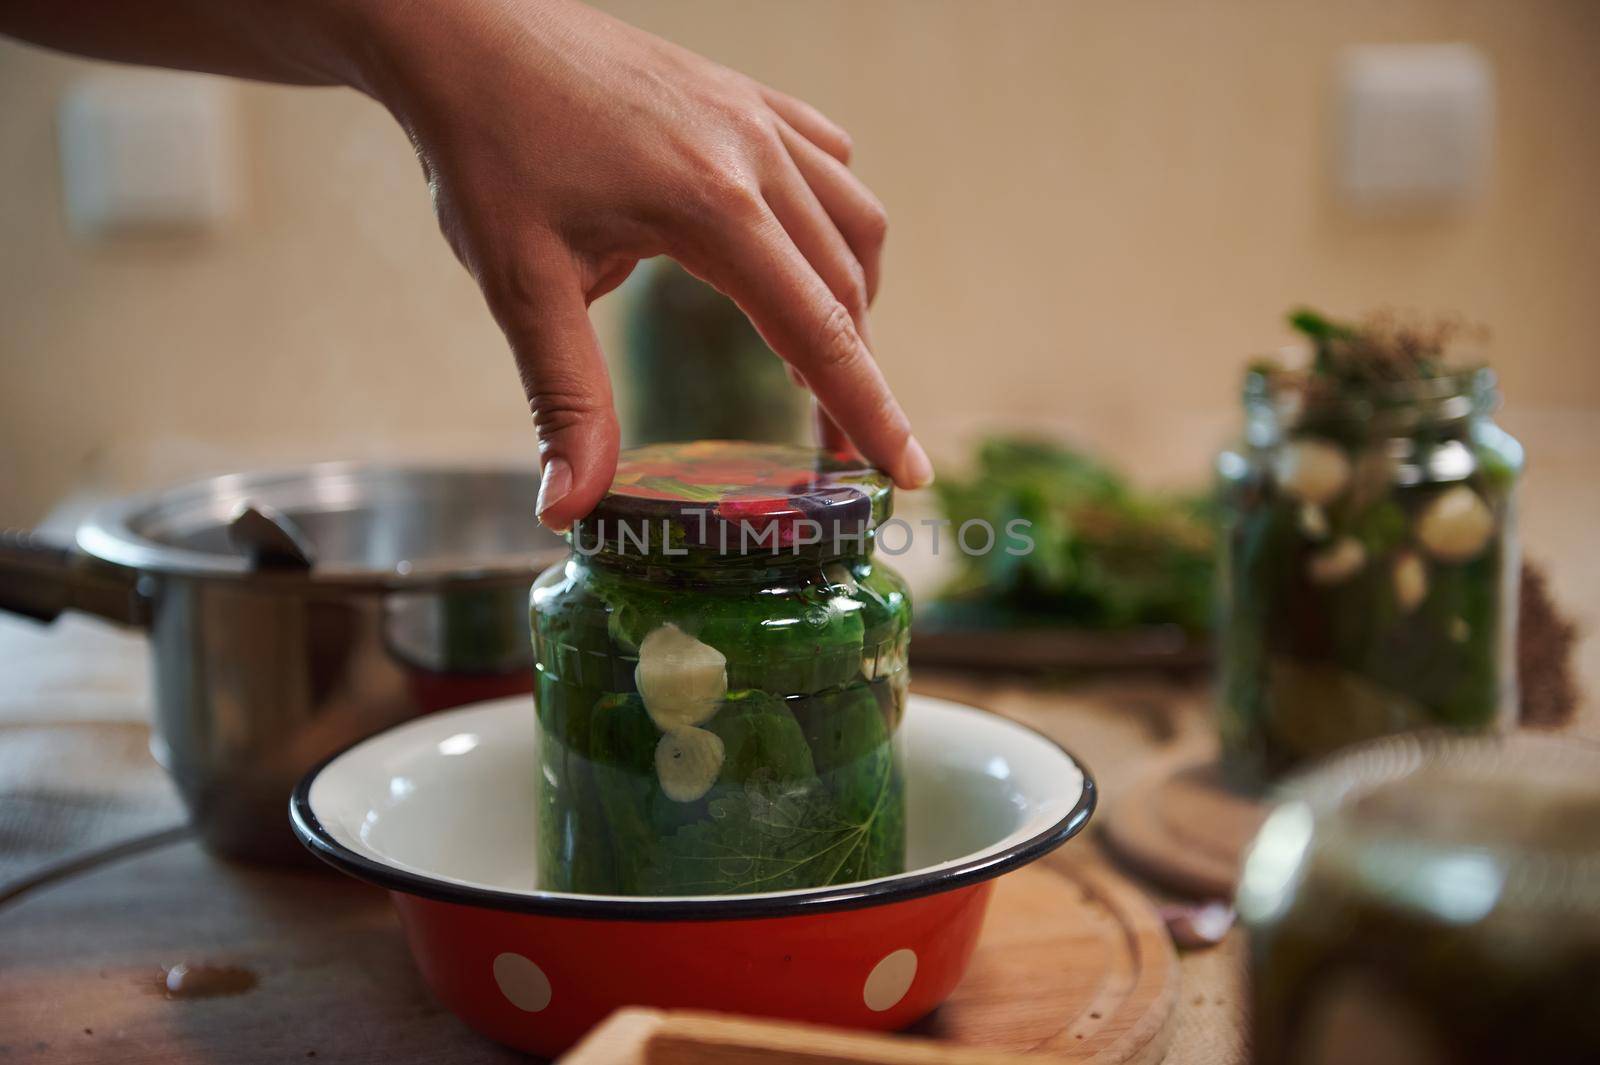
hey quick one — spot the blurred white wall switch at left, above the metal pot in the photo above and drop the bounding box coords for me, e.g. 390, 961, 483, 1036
59, 72, 238, 237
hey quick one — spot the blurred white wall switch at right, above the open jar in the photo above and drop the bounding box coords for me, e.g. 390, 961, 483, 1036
1336, 45, 1494, 211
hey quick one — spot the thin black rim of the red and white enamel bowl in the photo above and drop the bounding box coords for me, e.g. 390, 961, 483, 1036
290, 704, 1096, 921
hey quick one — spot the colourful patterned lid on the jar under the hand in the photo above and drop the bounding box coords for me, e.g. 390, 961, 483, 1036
573, 440, 894, 556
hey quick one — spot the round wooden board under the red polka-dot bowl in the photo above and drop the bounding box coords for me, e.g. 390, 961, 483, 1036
909, 859, 1178, 1065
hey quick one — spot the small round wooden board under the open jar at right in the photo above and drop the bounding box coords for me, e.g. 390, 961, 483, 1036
1104, 753, 1267, 899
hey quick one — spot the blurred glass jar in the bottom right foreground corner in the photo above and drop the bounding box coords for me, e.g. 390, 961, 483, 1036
1238, 732, 1600, 1065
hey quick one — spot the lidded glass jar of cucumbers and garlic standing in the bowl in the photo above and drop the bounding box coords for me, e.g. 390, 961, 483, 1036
531, 441, 910, 895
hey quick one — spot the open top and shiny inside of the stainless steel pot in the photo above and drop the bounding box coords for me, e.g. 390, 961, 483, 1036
77, 462, 565, 585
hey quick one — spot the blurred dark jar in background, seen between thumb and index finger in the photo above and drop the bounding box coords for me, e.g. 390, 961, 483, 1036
622, 259, 810, 446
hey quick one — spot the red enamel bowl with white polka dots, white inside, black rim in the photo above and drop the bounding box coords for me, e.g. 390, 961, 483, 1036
290, 694, 1094, 1055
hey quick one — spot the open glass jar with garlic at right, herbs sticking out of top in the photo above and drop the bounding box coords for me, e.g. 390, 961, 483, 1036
1218, 369, 1522, 782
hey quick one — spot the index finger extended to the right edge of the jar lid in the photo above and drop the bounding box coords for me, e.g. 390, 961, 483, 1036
680, 207, 933, 488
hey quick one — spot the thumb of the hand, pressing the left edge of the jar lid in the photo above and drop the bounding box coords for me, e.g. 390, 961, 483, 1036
485, 249, 619, 533
